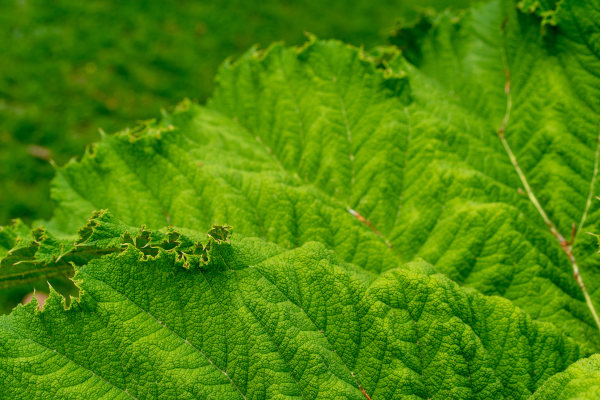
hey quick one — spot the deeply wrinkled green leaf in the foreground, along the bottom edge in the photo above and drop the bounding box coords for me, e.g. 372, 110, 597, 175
0, 214, 585, 399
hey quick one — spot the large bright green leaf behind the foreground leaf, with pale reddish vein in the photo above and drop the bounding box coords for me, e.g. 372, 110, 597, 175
42, 1, 600, 346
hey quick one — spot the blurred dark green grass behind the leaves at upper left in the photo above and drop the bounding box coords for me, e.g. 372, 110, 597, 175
0, 0, 468, 225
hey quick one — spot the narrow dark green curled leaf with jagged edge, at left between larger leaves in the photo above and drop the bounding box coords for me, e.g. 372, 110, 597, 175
0, 210, 231, 282
